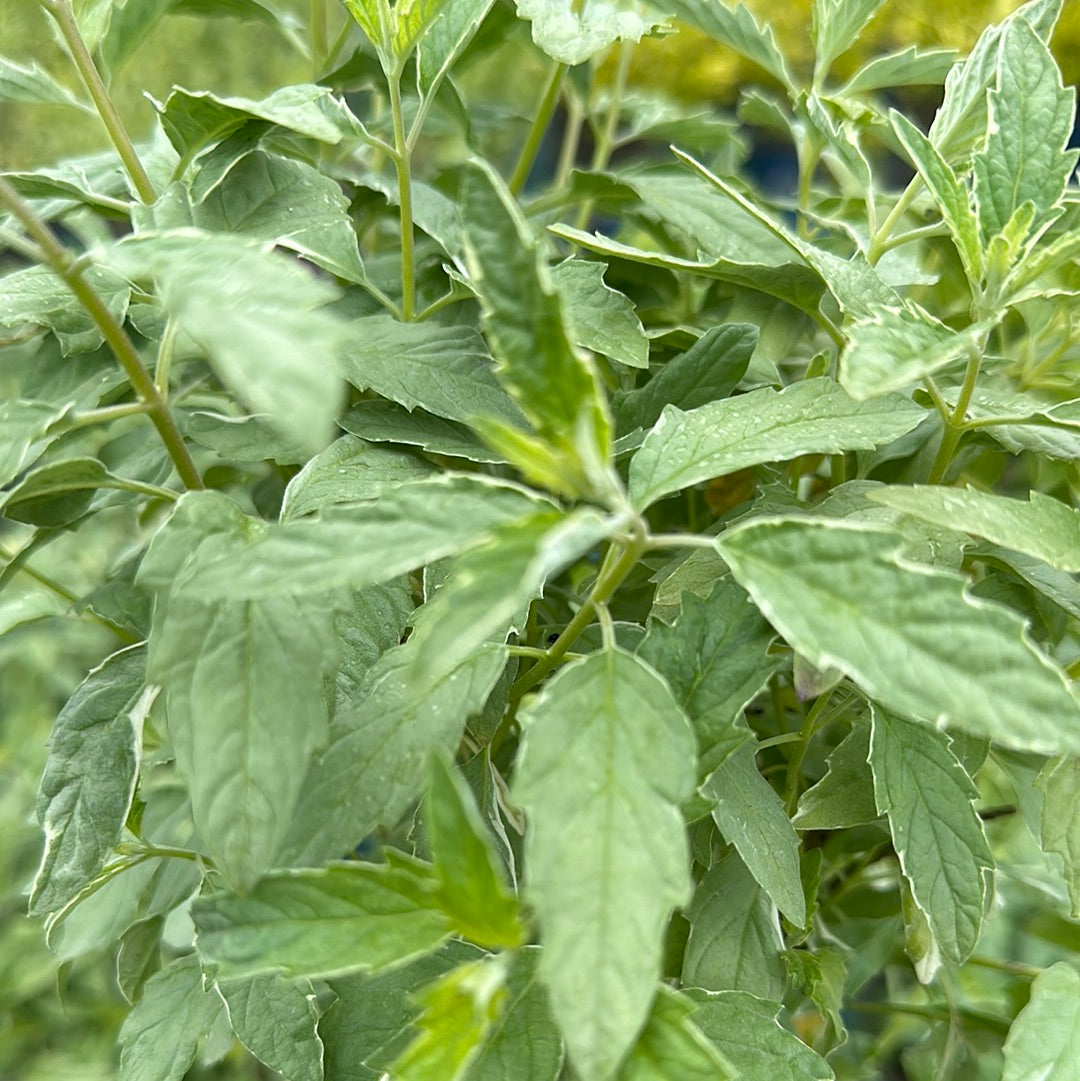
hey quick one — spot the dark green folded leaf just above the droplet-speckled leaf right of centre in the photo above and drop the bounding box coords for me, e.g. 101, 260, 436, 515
615, 323, 758, 431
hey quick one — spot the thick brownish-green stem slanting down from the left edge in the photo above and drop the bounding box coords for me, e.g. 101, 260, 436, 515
0, 176, 203, 489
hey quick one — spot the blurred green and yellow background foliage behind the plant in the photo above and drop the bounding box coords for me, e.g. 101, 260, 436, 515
0, 0, 1080, 1081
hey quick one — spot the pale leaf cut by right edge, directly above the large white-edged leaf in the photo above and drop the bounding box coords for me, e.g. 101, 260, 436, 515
867, 484, 1080, 573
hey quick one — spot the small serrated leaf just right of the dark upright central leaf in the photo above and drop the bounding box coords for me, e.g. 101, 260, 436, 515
551, 259, 649, 368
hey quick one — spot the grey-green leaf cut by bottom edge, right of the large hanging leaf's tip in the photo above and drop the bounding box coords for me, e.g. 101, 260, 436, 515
683, 988, 835, 1081
